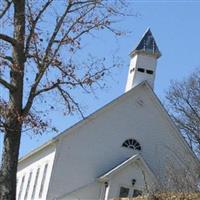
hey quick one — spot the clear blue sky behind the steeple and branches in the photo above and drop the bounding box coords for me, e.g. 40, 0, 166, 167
0, 0, 200, 159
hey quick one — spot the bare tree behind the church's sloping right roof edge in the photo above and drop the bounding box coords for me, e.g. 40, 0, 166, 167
166, 69, 200, 155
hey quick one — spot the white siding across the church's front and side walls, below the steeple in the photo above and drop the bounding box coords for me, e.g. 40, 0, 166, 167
17, 84, 198, 200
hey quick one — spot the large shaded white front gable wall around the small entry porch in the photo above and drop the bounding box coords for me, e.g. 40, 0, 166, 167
49, 83, 198, 198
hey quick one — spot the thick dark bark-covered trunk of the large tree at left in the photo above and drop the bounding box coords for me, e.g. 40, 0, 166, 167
0, 0, 25, 200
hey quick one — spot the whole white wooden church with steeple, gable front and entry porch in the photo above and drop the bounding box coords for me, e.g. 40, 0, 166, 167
17, 29, 199, 200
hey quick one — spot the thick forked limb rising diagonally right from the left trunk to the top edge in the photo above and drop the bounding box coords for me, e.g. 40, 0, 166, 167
23, 0, 122, 119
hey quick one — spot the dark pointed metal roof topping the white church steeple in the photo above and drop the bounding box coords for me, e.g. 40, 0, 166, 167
130, 28, 161, 58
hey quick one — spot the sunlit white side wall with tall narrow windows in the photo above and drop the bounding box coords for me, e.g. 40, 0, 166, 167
16, 147, 55, 200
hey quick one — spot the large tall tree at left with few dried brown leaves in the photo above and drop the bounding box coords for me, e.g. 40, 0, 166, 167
0, 0, 130, 200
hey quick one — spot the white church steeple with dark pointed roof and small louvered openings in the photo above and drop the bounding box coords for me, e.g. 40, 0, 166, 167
125, 29, 161, 92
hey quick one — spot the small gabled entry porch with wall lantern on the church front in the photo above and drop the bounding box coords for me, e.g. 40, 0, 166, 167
100, 155, 156, 199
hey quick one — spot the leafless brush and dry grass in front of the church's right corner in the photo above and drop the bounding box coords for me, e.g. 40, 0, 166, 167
140, 154, 200, 200
